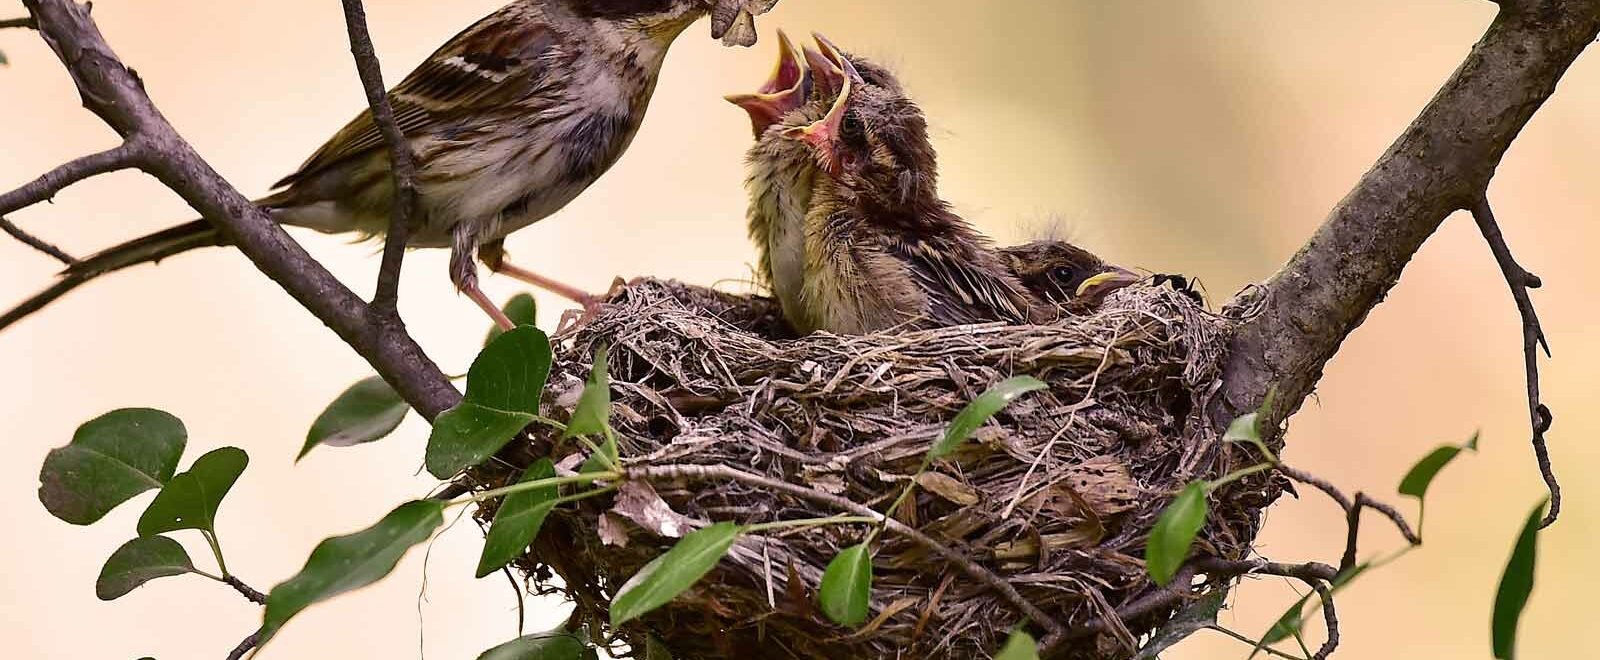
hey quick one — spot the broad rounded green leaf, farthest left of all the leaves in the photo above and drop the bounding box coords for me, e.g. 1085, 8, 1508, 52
38, 408, 189, 525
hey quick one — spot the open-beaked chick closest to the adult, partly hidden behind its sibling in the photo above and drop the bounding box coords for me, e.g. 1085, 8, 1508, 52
726, 32, 899, 330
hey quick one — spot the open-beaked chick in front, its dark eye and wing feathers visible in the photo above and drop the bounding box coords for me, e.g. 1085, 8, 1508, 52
781, 38, 1054, 333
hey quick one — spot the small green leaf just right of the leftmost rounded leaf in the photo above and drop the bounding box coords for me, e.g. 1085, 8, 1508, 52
139, 447, 250, 537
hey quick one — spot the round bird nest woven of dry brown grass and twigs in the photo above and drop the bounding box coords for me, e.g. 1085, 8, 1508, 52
474, 280, 1277, 660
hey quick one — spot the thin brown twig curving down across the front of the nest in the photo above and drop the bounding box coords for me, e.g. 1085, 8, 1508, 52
624, 465, 1066, 655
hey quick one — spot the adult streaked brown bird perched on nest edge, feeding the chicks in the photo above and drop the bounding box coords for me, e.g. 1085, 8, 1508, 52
0, 0, 771, 328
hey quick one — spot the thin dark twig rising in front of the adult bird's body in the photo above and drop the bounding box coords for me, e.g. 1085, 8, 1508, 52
342, 0, 416, 322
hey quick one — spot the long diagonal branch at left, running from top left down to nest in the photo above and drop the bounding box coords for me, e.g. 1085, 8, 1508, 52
24, 0, 461, 420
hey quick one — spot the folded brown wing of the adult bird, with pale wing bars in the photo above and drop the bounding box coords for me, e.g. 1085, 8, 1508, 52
274, 5, 565, 187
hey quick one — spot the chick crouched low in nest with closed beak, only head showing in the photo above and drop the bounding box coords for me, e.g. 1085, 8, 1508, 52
1000, 240, 1144, 314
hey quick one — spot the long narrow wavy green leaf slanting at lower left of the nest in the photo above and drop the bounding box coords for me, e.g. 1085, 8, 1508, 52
261, 500, 445, 644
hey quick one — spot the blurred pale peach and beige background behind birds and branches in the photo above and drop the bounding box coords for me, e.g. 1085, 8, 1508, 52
0, 0, 1600, 660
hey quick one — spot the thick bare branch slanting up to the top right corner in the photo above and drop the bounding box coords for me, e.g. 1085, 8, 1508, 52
1211, 0, 1600, 483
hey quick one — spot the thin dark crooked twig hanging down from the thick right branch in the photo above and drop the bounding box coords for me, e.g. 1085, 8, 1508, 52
1472, 195, 1562, 527
